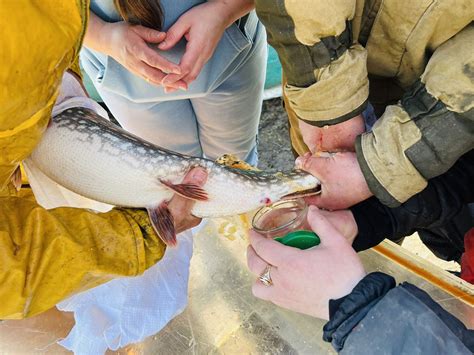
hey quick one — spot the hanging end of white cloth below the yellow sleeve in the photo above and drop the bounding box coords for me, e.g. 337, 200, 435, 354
57, 231, 193, 355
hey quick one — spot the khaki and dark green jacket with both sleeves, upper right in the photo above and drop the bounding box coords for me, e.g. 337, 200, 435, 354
255, 0, 474, 206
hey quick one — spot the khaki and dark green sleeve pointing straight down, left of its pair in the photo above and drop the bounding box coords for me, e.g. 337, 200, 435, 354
255, 0, 369, 126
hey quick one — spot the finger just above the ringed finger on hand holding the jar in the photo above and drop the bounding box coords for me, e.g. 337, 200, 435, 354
249, 230, 297, 266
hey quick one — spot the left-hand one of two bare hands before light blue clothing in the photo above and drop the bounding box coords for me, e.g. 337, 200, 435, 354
102, 22, 181, 85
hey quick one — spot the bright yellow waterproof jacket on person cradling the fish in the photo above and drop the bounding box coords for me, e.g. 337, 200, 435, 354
0, 0, 165, 319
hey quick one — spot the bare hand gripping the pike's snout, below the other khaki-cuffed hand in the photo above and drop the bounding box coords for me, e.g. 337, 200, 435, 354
296, 152, 372, 210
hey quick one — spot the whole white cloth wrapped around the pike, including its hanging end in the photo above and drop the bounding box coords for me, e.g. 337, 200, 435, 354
24, 73, 193, 355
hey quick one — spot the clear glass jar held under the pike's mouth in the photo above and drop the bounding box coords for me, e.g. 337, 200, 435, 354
252, 199, 311, 238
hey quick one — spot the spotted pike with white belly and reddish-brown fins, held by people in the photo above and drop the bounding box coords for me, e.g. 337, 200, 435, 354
30, 108, 319, 245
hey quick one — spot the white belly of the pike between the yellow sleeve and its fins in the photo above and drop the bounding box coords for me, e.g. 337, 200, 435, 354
31, 125, 172, 207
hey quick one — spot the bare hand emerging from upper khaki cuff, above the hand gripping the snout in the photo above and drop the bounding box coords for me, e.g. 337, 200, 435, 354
299, 115, 365, 153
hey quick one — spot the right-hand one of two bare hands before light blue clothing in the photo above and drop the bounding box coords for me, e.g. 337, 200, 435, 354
158, 2, 231, 92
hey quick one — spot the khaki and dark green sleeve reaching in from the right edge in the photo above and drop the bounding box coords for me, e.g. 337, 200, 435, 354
356, 25, 474, 207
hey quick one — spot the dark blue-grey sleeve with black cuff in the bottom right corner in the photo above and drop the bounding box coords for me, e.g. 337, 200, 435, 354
323, 272, 474, 354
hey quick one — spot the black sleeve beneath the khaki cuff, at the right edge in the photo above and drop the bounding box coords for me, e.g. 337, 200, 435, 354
351, 150, 474, 251
